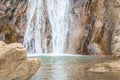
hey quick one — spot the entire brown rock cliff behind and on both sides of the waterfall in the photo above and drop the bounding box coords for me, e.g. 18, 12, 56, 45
0, 0, 120, 55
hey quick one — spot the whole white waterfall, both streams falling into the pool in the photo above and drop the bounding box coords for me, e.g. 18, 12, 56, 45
24, 0, 70, 53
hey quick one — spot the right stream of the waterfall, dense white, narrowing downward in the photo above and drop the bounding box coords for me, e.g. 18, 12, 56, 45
46, 0, 70, 53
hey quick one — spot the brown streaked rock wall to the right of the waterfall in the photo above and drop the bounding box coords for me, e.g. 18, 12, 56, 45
68, 0, 120, 55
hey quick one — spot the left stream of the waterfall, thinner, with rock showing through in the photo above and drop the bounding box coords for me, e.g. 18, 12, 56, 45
23, 0, 47, 53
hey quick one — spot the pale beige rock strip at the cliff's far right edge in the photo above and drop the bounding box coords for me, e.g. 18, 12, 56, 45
109, 0, 120, 56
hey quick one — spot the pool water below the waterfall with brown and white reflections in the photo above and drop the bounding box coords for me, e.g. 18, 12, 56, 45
31, 56, 120, 80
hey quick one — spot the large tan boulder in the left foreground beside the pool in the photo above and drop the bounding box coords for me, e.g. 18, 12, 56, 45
0, 42, 41, 80
